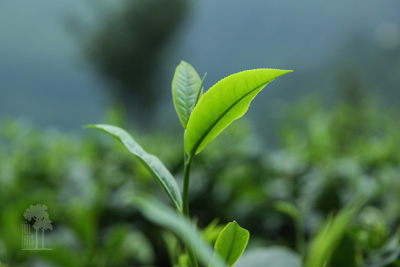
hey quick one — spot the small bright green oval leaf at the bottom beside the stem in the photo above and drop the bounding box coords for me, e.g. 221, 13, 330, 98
211, 221, 250, 266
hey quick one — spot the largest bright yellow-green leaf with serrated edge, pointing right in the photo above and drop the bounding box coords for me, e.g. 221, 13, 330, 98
185, 69, 291, 155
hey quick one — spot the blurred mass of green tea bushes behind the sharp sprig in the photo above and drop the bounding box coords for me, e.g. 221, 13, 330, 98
0, 99, 400, 266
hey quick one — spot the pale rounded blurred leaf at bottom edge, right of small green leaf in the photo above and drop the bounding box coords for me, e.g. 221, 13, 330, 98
235, 247, 300, 267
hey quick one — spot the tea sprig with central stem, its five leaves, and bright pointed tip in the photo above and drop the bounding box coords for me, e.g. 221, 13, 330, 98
88, 61, 291, 267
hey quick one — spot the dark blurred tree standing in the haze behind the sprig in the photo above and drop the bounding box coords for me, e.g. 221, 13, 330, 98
81, 0, 187, 119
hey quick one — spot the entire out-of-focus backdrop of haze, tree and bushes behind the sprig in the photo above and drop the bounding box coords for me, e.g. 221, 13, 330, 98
0, 0, 400, 267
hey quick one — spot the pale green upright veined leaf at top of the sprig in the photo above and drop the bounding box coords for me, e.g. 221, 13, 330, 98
172, 61, 203, 129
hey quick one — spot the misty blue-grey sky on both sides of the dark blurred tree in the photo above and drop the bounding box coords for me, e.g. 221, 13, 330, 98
0, 0, 400, 129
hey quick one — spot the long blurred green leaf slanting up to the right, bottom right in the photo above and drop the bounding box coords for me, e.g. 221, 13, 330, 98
305, 198, 365, 267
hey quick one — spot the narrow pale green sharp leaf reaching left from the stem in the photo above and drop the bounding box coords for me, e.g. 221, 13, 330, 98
87, 124, 182, 212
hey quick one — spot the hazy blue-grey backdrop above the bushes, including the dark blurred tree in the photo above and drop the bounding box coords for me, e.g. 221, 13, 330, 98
0, 0, 400, 138
